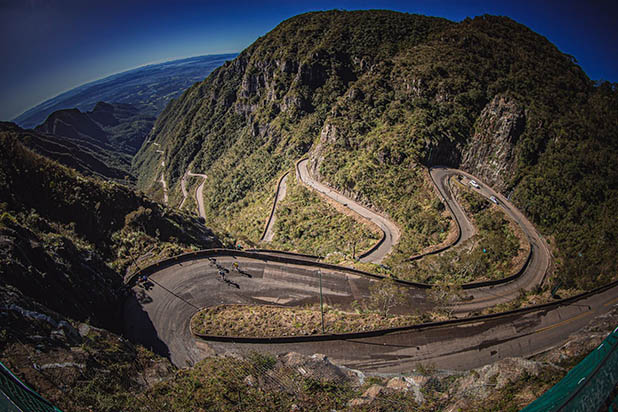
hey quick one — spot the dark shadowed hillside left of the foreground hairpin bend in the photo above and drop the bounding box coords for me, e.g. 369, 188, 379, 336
0, 128, 219, 330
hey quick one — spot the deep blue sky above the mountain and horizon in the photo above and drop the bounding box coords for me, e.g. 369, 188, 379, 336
0, 0, 618, 120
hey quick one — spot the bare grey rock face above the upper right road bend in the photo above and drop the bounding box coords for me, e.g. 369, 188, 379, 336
460, 95, 526, 190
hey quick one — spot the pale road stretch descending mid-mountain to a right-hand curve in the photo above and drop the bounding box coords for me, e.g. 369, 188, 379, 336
298, 159, 400, 263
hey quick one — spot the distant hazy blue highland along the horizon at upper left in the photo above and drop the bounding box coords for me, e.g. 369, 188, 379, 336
13, 54, 236, 129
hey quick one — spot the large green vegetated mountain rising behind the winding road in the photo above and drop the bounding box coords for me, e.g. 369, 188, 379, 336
133, 10, 618, 287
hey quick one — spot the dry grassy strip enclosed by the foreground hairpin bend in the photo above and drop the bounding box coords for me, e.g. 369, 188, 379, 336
191, 305, 420, 337
